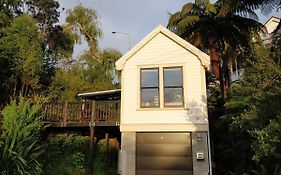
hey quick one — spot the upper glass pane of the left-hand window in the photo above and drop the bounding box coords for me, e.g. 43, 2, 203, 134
141, 68, 159, 87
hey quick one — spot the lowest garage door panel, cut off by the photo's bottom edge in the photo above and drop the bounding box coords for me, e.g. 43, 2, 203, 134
137, 170, 192, 175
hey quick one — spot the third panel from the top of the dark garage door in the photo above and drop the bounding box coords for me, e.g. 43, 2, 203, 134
137, 156, 192, 170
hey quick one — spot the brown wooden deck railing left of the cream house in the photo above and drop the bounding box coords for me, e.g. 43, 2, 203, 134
43, 101, 120, 127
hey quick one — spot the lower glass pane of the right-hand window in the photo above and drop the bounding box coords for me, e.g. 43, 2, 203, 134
164, 88, 183, 106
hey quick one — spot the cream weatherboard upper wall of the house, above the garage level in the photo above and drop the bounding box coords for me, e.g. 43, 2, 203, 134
120, 33, 208, 131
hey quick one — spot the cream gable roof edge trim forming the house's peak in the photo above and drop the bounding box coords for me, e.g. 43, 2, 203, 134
115, 25, 210, 70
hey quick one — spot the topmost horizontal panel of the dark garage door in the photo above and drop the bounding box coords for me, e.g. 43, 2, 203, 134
137, 133, 190, 145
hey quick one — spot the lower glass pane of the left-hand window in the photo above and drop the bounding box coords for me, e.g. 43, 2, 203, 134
141, 88, 159, 107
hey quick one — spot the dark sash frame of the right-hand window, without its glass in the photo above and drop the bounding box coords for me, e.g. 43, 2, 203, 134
163, 66, 184, 108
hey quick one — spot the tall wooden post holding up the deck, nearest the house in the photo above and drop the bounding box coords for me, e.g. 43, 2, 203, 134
88, 101, 96, 175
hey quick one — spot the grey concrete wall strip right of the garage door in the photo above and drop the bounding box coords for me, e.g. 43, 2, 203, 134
192, 132, 209, 175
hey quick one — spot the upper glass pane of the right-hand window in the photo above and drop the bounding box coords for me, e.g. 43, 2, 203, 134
164, 67, 182, 87
